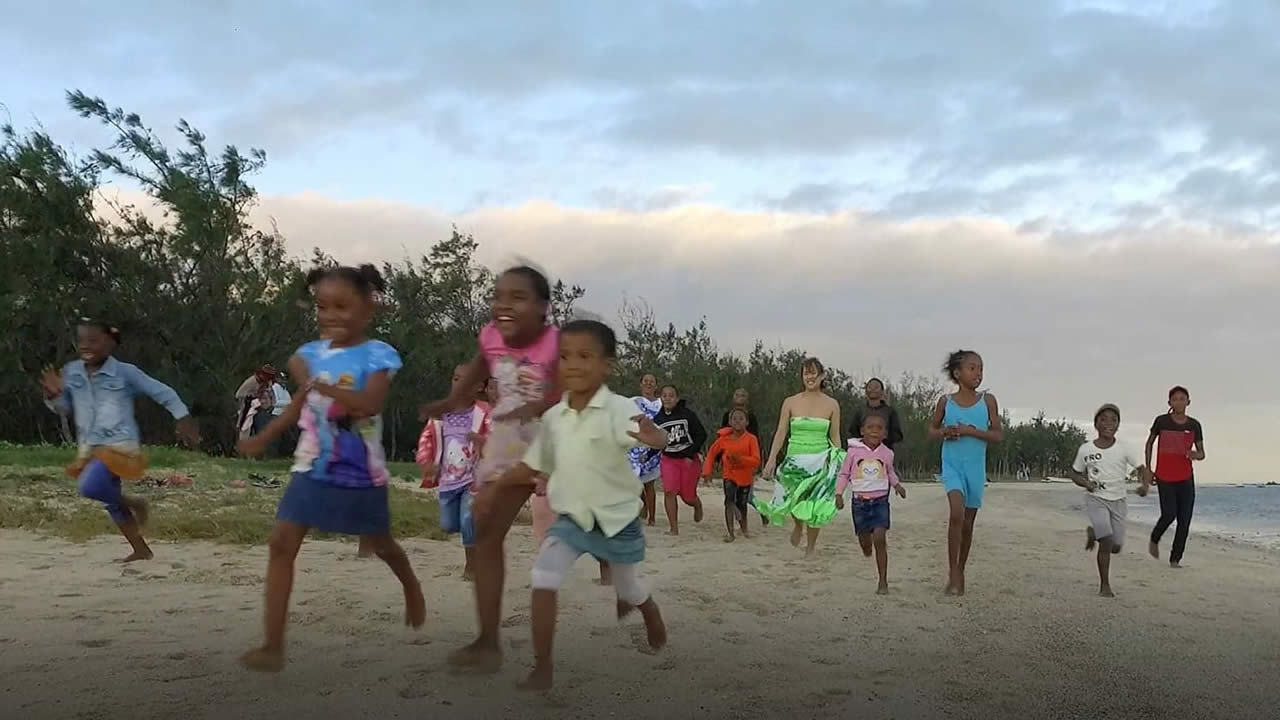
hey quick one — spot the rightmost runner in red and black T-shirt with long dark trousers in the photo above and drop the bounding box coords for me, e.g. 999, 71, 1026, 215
1146, 386, 1204, 568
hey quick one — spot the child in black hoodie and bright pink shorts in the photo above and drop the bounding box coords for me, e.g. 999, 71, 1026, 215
653, 384, 707, 536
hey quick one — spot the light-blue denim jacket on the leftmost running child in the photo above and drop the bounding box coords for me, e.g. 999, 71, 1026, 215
46, 357, 189, 452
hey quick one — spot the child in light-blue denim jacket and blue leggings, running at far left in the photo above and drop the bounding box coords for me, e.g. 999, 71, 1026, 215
40, 319, 200, 562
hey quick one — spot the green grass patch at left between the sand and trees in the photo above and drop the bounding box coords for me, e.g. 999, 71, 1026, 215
0, 445, 445, 544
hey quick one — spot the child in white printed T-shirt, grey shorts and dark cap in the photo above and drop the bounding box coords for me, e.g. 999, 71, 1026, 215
1071, 402, 1151, 597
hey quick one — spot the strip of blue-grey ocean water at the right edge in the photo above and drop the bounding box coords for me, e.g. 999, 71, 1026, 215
1129, 484, 1280, 550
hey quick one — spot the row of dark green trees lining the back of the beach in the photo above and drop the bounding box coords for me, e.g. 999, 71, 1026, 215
0, 91, 1083, 477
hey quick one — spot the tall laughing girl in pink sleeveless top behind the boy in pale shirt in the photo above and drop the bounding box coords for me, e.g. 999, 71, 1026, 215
419, 265, 601, 673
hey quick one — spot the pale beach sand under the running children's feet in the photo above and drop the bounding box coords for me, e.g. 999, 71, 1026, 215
0, 484, 1280, 720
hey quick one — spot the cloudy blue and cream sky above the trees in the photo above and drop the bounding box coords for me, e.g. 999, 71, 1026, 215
0, 0, 1280, 483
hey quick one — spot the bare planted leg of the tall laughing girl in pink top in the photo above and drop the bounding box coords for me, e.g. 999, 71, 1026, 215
448, 486, 530, 673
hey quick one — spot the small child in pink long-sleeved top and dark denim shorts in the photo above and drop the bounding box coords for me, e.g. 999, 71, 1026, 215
836, 415, 906, 594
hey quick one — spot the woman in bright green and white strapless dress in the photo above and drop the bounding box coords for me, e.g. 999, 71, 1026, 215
755, 357, 845, 557
